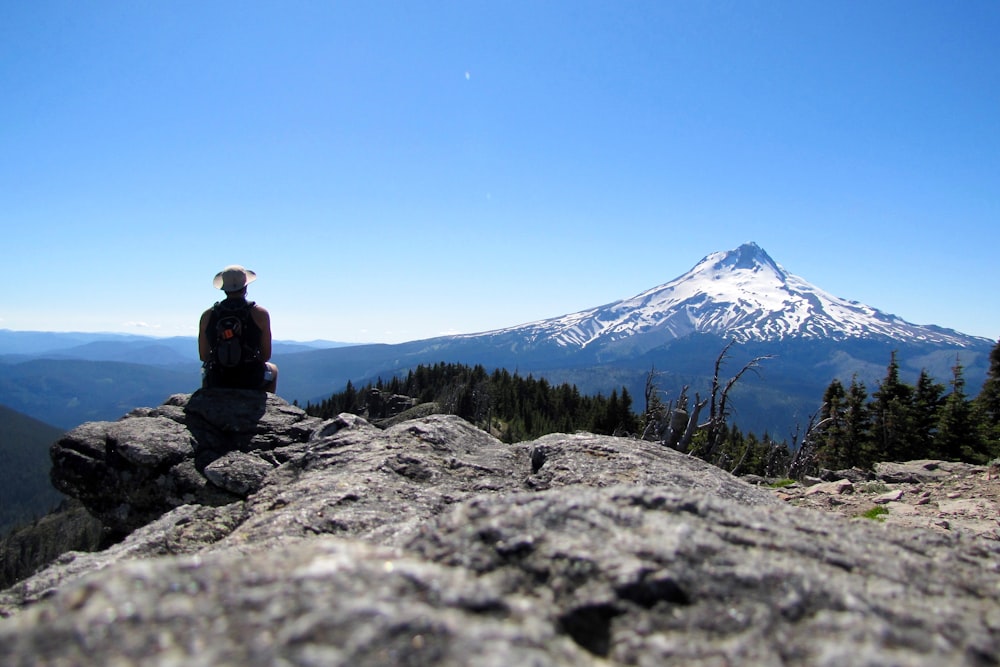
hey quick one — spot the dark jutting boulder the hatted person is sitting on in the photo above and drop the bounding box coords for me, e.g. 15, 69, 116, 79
51, 389, 320, 535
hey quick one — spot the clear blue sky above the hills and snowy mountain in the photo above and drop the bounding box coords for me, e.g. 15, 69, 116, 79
0, 0, 1000, 342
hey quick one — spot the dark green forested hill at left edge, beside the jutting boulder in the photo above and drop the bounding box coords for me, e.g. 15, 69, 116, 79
0, 405, 63, 534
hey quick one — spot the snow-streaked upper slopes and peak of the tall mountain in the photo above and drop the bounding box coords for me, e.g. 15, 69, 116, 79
475, 243, 983, 349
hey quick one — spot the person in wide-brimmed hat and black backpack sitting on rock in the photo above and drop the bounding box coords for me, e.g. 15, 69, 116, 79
198, 264, 278, 393
